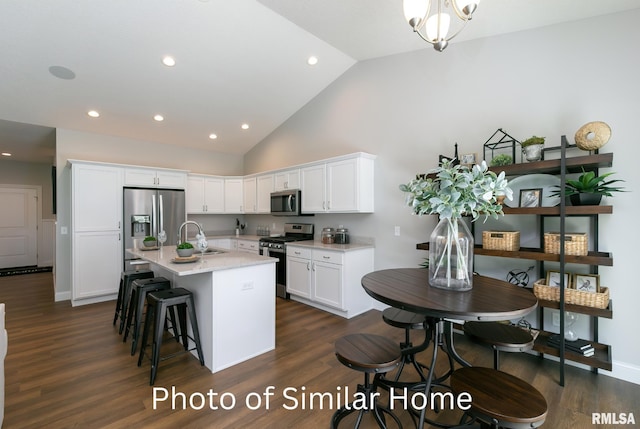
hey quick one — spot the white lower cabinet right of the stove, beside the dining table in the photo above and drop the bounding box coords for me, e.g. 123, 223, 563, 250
287, 245, 374, 318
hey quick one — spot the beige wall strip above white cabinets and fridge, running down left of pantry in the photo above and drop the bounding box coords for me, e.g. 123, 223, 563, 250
55, 129, 243, 300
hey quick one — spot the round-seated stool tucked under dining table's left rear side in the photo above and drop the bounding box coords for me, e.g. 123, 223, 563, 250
382, 307, 428, 381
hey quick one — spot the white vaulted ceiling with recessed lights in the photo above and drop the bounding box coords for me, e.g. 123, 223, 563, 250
0, 0, 640, 161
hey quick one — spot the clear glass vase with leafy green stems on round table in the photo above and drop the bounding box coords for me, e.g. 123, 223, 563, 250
400, 160, 513, 291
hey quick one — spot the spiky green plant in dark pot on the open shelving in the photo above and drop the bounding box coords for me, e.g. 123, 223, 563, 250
551, 168, 625, 206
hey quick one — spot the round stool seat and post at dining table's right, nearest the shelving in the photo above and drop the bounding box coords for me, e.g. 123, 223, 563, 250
463, 321, 535, 369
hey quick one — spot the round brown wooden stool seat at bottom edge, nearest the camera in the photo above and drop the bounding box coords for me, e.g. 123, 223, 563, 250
451, 367, 547, 429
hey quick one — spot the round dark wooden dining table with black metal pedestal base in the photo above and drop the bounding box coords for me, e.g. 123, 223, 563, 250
362, 268, 538, 429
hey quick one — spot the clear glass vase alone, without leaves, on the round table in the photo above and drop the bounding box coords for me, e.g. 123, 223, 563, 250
429, 218, 473, 291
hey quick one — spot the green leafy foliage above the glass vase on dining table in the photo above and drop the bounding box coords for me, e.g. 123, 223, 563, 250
400, 160, 513, 221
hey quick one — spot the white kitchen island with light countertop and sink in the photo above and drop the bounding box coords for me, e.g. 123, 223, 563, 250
128, 246, 277, 372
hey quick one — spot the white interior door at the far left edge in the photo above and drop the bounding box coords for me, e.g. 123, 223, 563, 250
0, 187, 38, 268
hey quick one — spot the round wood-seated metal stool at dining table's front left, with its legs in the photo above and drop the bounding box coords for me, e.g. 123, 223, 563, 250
331, 334, 402, 429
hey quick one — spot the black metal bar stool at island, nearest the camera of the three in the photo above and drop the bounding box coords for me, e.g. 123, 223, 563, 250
138, 288, 204, 385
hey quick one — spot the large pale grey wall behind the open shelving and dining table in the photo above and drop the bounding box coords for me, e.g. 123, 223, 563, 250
245, 10, 640, 383
